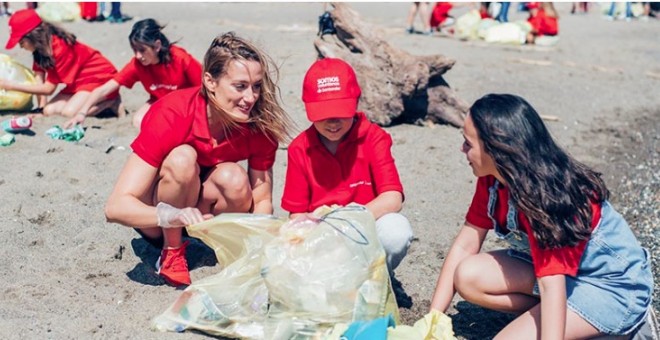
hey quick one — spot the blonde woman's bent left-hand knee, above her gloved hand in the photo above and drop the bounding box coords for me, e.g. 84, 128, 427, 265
161, 145, 199, 183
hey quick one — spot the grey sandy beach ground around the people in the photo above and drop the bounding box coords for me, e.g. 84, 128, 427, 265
0, 2, 660, 339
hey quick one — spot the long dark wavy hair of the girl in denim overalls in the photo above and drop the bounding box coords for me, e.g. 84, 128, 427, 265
470, 94, 609, 249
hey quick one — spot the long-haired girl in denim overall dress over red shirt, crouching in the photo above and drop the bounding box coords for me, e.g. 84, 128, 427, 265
431, 94, 653, 339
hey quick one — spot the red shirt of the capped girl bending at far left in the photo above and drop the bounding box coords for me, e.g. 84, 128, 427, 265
32, 35, 118, 95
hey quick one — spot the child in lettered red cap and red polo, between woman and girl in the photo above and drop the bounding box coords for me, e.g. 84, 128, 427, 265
282, 58, 413, 306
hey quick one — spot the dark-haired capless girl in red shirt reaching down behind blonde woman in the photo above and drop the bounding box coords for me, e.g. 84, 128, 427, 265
65, 19, 202, 128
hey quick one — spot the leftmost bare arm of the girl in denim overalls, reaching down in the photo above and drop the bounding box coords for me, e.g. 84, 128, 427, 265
431, 222, 488, 313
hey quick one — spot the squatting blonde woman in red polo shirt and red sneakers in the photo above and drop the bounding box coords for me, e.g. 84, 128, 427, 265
105, 32, 292, 286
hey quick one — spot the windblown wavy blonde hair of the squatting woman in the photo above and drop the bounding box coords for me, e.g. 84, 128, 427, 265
201, 32, 294, 143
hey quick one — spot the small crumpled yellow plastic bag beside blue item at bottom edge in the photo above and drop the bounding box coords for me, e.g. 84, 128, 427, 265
387, 310, 456, 340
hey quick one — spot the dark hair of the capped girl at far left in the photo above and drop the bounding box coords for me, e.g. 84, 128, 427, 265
23, 21, 76, 70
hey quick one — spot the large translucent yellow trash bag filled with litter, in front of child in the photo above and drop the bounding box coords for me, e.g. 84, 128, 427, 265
152, 205, 398, 339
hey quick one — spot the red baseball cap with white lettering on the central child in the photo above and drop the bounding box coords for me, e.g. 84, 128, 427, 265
303, 58, 362, 122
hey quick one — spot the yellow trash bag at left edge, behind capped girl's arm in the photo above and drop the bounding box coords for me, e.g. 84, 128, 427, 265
0, 53, 36, 111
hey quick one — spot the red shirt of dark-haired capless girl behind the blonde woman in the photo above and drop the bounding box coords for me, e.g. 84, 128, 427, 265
114, 45, 202, 101
